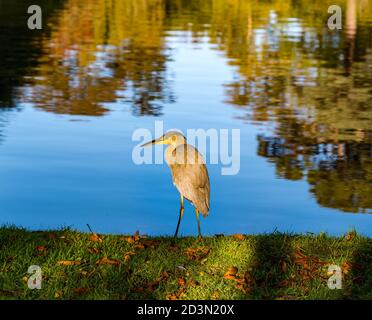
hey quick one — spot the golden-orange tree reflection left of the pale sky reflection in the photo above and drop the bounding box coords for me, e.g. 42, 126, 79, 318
24, 0, 173, 116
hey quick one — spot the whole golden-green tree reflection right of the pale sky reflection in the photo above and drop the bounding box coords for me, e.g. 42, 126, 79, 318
203, 0, 372, 212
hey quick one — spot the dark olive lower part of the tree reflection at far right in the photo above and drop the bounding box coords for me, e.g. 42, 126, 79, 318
258, 136, 372, 213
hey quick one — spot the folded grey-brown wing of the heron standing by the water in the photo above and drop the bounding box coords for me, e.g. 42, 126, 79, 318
170, 144, 210, 216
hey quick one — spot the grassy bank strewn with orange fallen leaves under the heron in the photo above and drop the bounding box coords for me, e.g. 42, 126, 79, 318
0, 228, 372, 299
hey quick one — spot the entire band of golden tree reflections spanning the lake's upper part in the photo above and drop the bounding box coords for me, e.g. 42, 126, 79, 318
0, 0, 372, 230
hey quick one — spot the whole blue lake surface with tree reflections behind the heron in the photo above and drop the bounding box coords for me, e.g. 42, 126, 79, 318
0, 0, 372, 236
